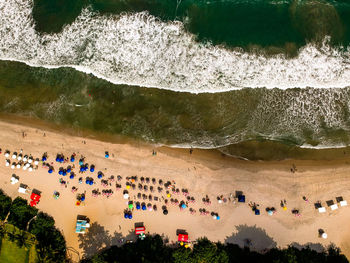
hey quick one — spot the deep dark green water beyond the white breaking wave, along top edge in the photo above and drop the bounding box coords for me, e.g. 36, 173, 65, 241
33, 0, 350, 55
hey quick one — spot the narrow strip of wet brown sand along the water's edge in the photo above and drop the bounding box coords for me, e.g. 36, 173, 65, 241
0, 113, 350, 162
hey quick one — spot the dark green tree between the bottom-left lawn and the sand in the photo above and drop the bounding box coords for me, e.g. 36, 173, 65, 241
29, 212, 66, 262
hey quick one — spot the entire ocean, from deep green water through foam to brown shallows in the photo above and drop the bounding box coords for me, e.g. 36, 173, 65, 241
0, 0, 350, 151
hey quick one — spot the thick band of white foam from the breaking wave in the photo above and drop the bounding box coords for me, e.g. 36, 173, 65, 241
0, 0, 350, 93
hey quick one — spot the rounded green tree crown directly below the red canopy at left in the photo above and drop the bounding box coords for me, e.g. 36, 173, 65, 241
8, 197, 38, 230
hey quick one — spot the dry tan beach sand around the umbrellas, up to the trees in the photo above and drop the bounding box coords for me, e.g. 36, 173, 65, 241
0, 122, 350, 259
